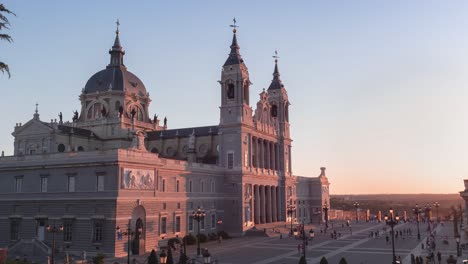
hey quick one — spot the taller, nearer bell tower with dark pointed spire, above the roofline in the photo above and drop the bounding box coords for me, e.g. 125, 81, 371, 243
219, 20, 252, 126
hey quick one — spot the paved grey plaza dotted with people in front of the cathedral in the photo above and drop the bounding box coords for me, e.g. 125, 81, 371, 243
106, 221, 468, 264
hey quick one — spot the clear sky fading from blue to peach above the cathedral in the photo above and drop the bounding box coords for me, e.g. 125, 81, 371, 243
0, 0, 468, 194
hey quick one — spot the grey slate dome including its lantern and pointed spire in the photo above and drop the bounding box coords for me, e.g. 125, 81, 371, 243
83, 29, 147, 96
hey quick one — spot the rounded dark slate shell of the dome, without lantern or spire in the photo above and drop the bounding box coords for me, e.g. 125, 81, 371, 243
83, 66, 146, 96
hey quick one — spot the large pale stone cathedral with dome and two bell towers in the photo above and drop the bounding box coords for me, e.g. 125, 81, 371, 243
0, 23, 329, 256
